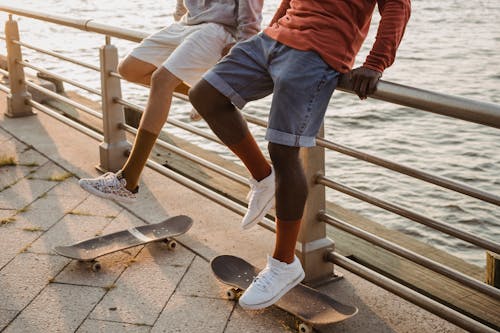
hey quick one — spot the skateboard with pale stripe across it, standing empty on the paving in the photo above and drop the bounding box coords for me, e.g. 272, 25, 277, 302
54, 215, 193, 272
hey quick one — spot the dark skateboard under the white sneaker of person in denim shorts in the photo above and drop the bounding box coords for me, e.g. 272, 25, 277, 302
210, 255, 358, 333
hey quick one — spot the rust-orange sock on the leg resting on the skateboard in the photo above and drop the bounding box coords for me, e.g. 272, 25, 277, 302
273, 218, 301, 264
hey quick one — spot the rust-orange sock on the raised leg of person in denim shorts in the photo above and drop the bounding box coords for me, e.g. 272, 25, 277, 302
229, 132, 271, 181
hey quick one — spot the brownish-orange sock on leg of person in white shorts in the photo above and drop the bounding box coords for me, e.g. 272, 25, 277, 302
122, 129, 158, 191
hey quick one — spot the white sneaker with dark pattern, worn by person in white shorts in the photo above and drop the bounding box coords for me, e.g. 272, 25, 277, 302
78, 171, 137, 202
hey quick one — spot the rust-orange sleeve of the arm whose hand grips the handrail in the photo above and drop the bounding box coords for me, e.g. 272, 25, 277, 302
363, 0, 411, 73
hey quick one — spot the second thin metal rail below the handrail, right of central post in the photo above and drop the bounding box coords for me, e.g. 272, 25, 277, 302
316, 175, 500, 253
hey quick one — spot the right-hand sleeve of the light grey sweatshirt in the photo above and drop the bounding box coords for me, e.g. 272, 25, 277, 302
236, 0, 263, 41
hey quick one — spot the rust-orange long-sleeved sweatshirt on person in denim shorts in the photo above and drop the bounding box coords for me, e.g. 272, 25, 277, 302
264, 0, 411, 73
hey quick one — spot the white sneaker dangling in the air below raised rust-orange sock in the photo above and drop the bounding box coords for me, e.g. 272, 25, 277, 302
241, 167, 276, 229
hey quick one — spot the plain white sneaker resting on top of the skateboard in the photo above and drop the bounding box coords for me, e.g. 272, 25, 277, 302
239, 256, 305, 310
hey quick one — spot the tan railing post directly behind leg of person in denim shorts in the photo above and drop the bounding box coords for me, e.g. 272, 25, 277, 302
295, 128, 335, 285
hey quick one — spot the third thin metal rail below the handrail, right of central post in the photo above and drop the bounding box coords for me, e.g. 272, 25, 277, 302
318, 212, 500, 299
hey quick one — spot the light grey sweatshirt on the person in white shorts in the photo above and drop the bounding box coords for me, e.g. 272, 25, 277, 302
174, 0, 263, 41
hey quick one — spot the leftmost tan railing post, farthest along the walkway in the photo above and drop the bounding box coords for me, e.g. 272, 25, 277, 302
5, 15, 35, 118
